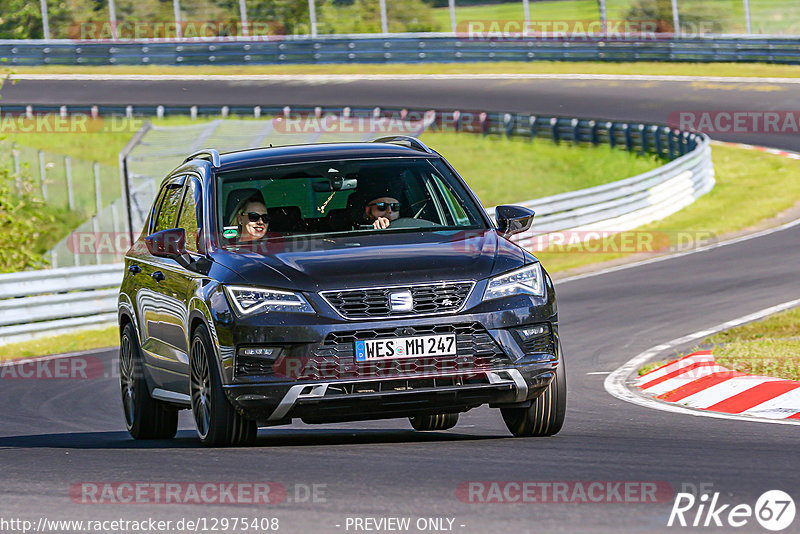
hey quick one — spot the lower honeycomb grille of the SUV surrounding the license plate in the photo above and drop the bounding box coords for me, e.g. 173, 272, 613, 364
285, 323, 509, 380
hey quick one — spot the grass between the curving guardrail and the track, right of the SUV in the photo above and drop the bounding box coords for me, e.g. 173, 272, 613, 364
536, 145, 800, 272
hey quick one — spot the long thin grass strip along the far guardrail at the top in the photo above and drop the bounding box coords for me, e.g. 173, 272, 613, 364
9, 61, 800, 78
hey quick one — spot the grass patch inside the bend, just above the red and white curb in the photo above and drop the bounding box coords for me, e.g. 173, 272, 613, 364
703, 308, 800, 380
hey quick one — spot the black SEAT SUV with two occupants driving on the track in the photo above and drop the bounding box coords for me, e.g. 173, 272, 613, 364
119, 137, 566, 446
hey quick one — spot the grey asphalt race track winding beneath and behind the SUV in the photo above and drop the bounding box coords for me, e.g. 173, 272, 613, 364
0, 76, 800, 534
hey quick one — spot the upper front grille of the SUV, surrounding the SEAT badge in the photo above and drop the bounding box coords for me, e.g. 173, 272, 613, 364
321, 282, 475, 319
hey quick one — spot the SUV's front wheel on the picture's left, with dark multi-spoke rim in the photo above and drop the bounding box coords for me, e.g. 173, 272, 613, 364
189, 326, 258, 447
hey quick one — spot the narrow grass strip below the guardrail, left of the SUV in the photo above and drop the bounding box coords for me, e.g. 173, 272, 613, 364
0, 325, 119, 361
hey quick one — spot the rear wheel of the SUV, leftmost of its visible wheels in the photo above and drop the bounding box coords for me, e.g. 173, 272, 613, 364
119, 323, 178, 439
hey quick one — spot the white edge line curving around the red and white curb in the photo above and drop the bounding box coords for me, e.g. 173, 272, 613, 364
603, 300, 800, 425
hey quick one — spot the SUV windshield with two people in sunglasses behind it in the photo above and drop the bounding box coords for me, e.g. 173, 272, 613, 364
217, 158, 486, 247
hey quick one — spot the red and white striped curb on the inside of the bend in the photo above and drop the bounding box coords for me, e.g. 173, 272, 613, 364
635, 350, 800, 419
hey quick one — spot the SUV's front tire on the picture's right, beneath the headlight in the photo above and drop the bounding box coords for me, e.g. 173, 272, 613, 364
500, 344, 567, 438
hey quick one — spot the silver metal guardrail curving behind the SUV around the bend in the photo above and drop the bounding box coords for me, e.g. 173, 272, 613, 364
0, 107, 714, 344
